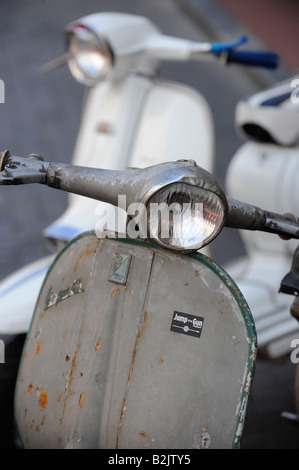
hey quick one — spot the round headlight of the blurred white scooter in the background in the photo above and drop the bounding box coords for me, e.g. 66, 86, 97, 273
66, 24, 113, 86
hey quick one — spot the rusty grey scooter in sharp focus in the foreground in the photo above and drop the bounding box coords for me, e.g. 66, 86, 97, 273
0, 152, 299, 449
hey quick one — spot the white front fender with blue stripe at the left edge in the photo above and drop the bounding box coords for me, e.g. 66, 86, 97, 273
0, 255, 54, 335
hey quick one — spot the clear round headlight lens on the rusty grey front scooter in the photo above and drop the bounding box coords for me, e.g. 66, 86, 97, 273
147, 183, 225, 251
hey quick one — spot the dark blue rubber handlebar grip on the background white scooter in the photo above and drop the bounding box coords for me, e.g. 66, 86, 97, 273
227, 50, 279, 69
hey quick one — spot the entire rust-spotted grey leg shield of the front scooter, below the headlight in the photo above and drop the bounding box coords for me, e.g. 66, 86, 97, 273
15, 233, 256, 449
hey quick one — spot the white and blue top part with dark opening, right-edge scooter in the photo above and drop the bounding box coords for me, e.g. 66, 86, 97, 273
235, 76, 299, 147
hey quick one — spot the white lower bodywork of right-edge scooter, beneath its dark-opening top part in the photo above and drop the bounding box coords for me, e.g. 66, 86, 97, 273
225, 142, 299, 358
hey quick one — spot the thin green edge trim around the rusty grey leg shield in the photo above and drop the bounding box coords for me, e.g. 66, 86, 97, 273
14, 230, 257, 449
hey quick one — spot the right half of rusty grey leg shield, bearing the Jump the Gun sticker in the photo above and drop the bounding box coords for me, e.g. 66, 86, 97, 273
118, 252, 254, 449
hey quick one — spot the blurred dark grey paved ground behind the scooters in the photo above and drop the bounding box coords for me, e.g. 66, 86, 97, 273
0, 0, 299, 449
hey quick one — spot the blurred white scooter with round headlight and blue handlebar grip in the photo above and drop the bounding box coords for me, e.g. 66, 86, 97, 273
0, 13, 277, 335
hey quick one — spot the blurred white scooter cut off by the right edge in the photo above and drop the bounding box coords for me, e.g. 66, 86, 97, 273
226, 77, 299, 358
